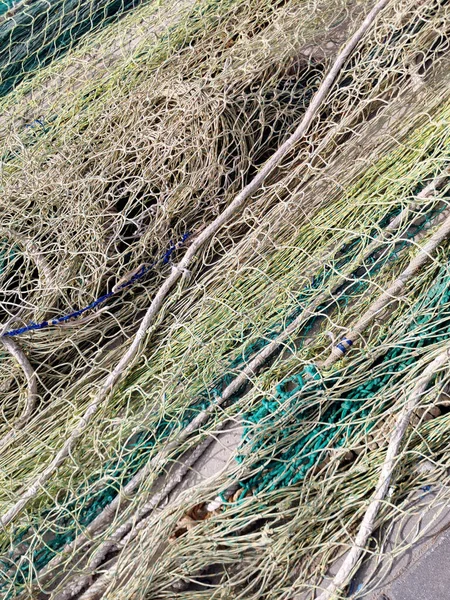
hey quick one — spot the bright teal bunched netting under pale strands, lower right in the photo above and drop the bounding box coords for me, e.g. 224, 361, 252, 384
241, 213, 450, 492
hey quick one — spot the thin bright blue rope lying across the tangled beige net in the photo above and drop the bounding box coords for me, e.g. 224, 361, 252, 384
0, 231, 191, 337
